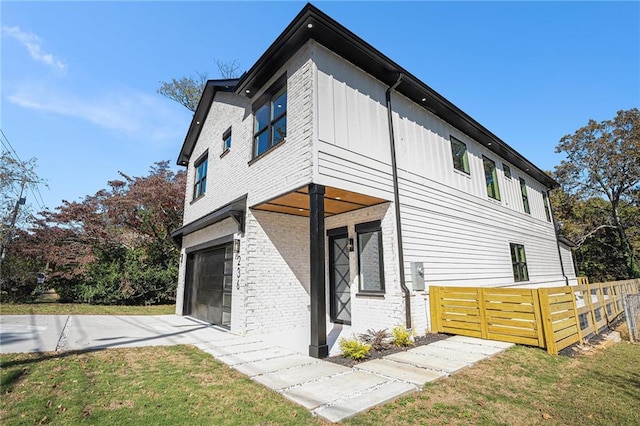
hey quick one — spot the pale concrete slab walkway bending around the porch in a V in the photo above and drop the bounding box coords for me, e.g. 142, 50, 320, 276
196, 336, 513, 422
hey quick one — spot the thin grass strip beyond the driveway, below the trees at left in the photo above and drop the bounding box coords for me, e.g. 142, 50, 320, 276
0, 301, 176, 315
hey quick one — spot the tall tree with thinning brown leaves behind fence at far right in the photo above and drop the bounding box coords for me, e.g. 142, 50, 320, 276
554, 108, 640, 278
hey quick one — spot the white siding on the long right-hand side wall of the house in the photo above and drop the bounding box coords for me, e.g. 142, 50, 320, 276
313, 45, 564, 286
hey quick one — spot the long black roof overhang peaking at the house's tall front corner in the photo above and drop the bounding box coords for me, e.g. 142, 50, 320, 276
236, 4, 559, 189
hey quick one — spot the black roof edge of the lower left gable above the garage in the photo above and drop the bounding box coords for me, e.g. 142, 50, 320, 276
176, 78, 238, 166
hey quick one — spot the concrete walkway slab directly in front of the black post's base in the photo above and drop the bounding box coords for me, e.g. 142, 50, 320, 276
253, 361, 351, 390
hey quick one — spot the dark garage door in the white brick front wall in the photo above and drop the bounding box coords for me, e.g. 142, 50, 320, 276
185, 244, 233, 327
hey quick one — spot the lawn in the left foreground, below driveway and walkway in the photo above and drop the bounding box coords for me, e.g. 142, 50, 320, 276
0, 346, 320, 426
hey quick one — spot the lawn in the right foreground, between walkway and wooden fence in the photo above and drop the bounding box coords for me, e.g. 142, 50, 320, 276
345, 334, 640, 425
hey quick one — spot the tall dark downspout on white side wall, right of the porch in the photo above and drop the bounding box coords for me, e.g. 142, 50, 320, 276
386, 73, 411, 330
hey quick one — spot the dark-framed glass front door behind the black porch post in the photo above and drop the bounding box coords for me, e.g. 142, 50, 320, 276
329, 229, 351, 324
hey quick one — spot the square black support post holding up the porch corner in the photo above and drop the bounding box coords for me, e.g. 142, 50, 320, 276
309, 183, 329, 358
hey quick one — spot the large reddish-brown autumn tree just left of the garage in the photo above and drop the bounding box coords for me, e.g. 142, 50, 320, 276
30, 161, 185, 304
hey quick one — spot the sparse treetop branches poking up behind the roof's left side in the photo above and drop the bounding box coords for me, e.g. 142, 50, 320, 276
158, 59, 240, 112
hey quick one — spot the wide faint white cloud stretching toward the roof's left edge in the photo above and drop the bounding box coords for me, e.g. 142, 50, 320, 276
7, 84, 189, 143
